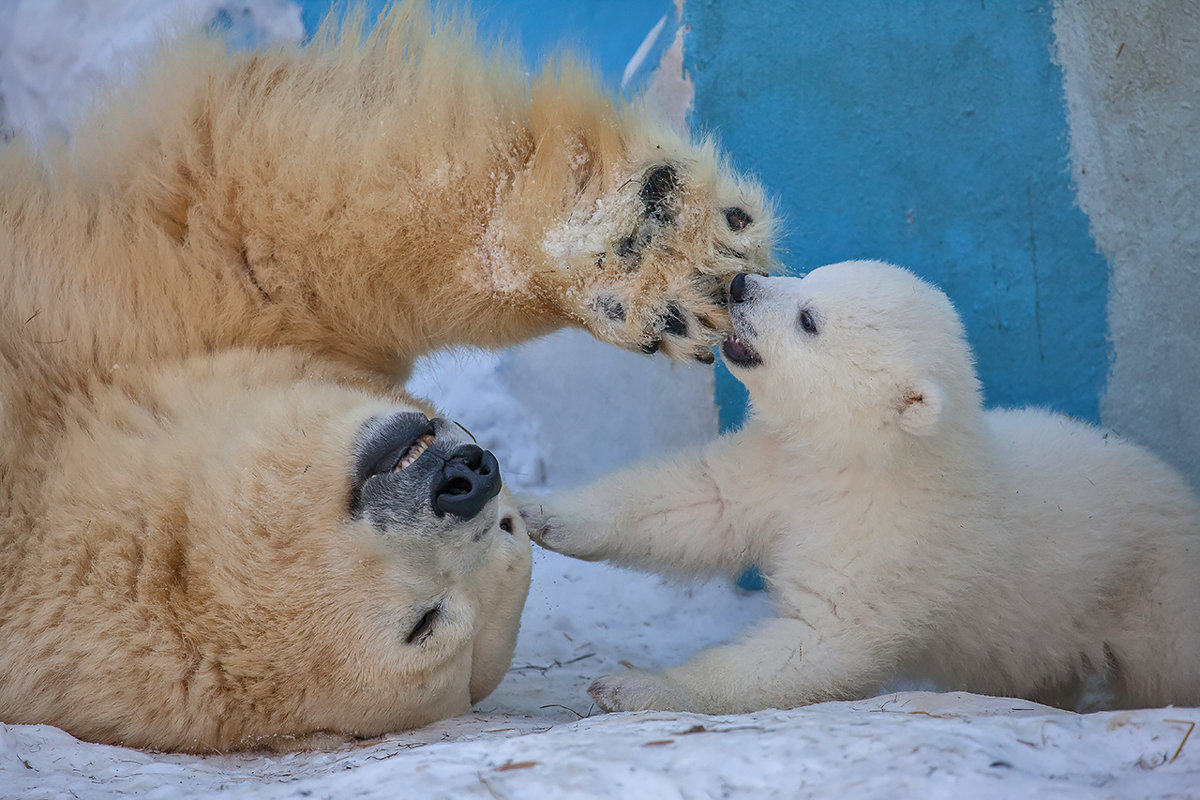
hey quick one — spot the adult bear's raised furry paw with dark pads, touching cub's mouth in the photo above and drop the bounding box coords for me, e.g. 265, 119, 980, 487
545, 160, 775, 363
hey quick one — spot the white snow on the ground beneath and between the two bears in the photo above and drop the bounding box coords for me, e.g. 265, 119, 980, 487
0, 354, 1200, 800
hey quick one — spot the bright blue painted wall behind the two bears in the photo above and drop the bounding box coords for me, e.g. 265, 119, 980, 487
301, 0, 1109, 428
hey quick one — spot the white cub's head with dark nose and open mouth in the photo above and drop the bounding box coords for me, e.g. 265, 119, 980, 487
721, 261, 979, 443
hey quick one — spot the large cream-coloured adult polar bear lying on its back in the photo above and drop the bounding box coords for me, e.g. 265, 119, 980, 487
0, 2, 772, 751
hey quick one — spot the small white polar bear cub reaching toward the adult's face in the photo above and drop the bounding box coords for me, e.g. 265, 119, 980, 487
526, 261, 1200, 714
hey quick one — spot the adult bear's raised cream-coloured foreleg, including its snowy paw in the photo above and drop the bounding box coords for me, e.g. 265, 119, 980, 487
0, 1, 773, 378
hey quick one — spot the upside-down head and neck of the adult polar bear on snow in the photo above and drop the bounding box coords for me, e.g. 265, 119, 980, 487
16, 351, 530, 752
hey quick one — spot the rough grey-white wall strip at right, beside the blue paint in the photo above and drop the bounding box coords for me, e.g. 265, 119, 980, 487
1054, 0, 1200, 487
